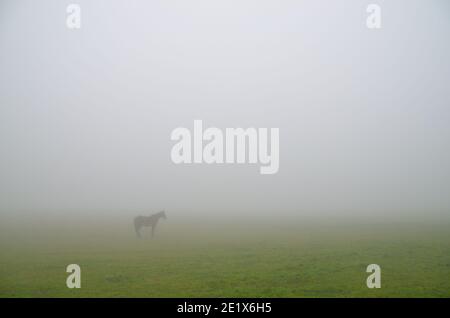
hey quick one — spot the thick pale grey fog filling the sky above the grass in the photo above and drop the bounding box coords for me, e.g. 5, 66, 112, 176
0, 0, 450, 226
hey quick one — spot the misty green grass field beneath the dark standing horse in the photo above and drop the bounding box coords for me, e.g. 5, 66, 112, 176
0, 219, 450, 297
